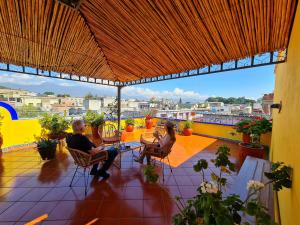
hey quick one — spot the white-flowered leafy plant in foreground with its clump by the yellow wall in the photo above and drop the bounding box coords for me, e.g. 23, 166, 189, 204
173, 146, 291, 225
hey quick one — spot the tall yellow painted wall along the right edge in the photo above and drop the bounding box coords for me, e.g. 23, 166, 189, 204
271, 4, 300, 225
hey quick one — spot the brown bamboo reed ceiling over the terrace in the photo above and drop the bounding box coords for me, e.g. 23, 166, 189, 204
0, 0, 297, 82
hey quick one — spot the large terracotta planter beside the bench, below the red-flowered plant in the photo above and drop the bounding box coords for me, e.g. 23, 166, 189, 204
239, 143, 266, 165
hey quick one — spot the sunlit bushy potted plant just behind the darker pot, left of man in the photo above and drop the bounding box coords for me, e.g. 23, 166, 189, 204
39, 114, 70, 140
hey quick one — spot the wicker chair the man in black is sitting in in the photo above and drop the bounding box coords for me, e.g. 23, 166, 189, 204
67, 147, 108, 196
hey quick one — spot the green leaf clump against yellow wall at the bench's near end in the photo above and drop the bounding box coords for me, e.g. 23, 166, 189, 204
265, 162, 292, 191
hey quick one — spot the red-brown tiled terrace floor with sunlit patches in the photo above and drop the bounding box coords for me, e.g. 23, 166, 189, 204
0, 131, 237, 225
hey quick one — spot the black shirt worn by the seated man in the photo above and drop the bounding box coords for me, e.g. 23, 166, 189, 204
66, 134, 96, 153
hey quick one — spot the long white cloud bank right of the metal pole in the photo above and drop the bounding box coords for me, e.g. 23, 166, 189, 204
122, 87, 207, 101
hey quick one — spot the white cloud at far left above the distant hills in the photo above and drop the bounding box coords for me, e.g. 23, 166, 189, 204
0, 73, 46, 86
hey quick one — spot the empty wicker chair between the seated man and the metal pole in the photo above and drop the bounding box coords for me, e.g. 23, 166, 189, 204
98, 124, 121, 145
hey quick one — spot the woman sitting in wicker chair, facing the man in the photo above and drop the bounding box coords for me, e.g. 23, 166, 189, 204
135, 121, 176, 165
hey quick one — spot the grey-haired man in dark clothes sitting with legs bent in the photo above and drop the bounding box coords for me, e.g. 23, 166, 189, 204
66, 120, 118, 179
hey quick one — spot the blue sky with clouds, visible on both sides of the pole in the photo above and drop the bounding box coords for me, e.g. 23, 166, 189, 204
0, 66, 275, 102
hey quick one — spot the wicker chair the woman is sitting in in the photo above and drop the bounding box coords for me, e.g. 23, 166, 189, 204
146, 141, 175, 182
